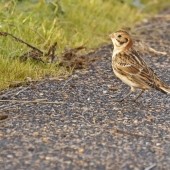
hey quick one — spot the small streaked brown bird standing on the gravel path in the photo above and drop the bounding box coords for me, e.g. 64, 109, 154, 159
109, 30, 170, 102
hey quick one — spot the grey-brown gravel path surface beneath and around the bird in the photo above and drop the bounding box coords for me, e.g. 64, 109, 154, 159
0, 11, 170, 170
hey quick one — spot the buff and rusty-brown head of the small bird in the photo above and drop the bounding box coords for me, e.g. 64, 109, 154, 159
110, 30, 132, 52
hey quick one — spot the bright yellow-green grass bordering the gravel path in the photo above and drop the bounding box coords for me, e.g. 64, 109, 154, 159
0, 0, 168, 89
